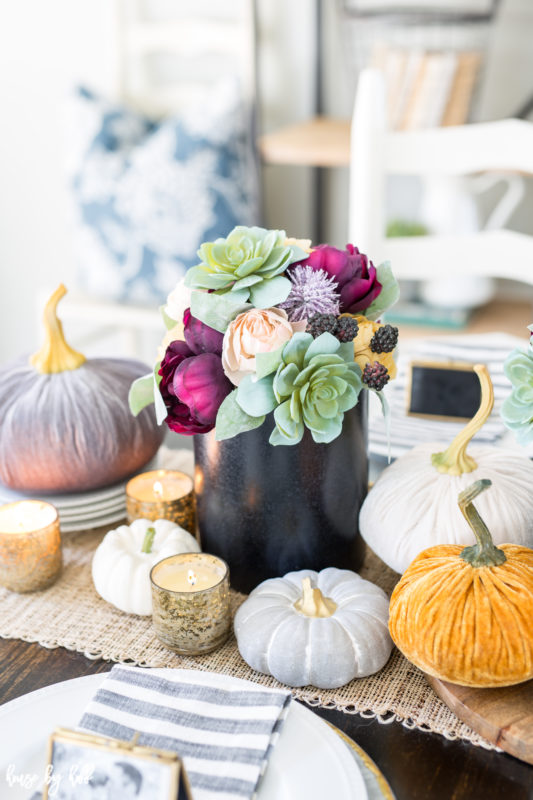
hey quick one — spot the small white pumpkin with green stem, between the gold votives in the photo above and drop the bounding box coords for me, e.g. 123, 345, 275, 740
92, 519, 200, 616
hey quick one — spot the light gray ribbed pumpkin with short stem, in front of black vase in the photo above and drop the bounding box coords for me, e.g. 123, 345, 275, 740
235, 567, 392, 689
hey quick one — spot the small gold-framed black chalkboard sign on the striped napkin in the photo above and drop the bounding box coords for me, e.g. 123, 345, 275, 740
407, 361, 481, 422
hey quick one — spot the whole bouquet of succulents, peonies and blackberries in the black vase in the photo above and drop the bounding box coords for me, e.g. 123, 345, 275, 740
130, 226, 398, 445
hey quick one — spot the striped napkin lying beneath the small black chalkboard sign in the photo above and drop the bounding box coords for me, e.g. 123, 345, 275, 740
368, 333, 527, 458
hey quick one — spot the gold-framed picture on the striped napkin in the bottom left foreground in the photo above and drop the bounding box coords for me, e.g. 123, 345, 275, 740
43, 728, 192, 800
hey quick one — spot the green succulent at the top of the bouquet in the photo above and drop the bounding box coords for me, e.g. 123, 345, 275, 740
185, 225, 307, 308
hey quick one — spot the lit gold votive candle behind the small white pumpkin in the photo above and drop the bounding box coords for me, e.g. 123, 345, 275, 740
126, 469, 196, 536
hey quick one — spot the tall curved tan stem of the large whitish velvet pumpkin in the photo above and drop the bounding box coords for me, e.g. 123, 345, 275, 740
431, 364, 494, 475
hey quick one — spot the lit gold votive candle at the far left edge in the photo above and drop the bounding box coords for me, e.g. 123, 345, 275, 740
0, 500, 63, 592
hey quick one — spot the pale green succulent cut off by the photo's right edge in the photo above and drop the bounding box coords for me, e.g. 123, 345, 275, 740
501, 325, 533, 445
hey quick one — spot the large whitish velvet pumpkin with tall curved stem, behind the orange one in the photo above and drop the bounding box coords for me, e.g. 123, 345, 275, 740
359, 364, 533, 573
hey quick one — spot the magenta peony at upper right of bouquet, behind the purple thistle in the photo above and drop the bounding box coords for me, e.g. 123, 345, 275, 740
294, 244, 382, 314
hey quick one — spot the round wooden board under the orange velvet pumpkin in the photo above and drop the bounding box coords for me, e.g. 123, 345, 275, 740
426, 675, 533, 764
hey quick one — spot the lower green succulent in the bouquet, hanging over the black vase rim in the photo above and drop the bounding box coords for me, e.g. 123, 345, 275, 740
231, 333, 363, 445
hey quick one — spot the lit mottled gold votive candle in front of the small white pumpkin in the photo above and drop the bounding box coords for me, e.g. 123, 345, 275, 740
150, 553, 231, 656
